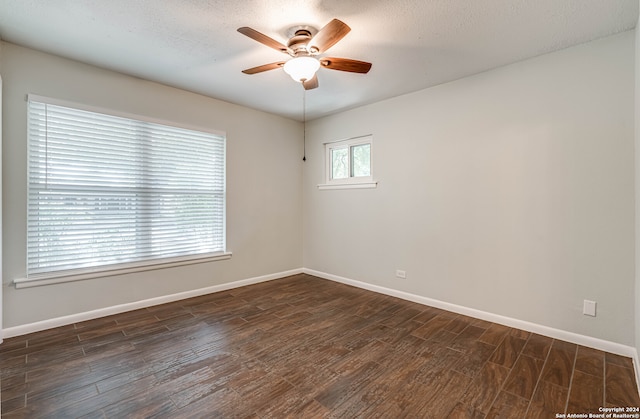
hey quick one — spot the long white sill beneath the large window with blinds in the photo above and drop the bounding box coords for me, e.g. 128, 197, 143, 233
13, 252, 232, 289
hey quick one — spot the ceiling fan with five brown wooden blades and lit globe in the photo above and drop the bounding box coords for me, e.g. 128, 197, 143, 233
238, 19, 371, 90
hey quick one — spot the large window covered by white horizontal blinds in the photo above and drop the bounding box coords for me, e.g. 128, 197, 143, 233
27, 96, 225, 280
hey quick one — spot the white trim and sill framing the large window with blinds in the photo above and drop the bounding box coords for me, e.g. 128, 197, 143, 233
14, 94, 231, 288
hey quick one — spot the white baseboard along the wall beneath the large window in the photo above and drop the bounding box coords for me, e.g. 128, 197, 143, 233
3, 269, 303, 339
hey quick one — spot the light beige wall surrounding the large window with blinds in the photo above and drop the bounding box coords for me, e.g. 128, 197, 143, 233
0, 43, 302, 328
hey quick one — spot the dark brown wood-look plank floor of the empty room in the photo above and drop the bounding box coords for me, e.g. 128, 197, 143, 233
0, 275, 640, 418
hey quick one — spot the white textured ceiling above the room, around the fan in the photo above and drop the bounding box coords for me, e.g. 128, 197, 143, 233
0, 0, 638, 120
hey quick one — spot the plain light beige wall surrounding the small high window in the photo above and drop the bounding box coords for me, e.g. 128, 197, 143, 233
303, 31, 635, 346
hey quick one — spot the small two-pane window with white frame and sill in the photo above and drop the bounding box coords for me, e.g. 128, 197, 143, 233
319, 135, 376, 189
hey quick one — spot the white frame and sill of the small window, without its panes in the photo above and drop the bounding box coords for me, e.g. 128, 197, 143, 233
318, 134, 378, 189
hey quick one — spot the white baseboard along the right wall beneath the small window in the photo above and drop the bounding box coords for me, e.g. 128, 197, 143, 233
302, 268, 638, 362
